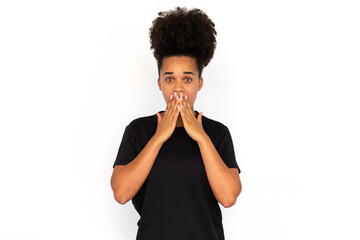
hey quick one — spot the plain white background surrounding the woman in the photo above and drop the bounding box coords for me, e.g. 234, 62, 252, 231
0, 0, 360, 240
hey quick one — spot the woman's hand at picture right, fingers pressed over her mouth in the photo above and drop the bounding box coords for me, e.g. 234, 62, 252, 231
180, 96, 206, 142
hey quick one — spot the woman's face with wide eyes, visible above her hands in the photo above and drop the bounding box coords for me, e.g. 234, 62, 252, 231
158, 56, 203, 110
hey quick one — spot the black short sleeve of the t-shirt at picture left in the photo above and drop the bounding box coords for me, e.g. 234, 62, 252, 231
113, 124, 137, 168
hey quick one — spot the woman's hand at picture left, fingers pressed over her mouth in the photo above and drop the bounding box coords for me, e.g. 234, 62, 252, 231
155, 95, 182, 142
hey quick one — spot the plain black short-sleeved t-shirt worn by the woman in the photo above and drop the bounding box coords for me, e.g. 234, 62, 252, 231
113, 111, 241, 240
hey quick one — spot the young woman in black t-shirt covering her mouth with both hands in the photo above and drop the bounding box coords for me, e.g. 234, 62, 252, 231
111, 7, 242, 240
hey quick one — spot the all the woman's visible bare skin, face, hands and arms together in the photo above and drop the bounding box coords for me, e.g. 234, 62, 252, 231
111, 57, 242, 207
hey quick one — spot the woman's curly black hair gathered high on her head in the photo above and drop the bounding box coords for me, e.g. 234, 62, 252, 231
149, 7, 217, 77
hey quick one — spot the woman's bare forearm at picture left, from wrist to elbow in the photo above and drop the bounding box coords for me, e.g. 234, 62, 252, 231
112, 134, 163, 204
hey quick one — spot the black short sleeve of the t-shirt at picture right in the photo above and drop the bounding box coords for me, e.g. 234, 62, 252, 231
217, 126, 241, 174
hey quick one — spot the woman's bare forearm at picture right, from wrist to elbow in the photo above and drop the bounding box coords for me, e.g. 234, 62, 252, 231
198, 133, 241, 207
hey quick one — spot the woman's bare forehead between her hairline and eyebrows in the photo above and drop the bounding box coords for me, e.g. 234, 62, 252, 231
161, 56, 197, 72
